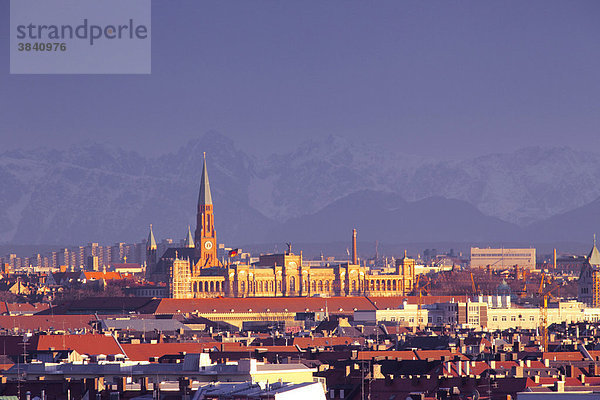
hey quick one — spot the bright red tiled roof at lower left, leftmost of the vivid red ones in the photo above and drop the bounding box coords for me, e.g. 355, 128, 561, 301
37, 334, 123, 355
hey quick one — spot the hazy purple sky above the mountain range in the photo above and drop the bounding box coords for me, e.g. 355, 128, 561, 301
0, 0, 600, 157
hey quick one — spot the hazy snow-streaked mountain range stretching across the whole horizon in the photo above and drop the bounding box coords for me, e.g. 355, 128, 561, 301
0, 132, 600, 244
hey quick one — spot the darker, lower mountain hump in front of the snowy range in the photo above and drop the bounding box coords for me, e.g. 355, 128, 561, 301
269, 191, 521, 243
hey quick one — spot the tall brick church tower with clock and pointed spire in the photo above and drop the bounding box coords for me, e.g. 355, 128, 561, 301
194, 153, 217, 268
